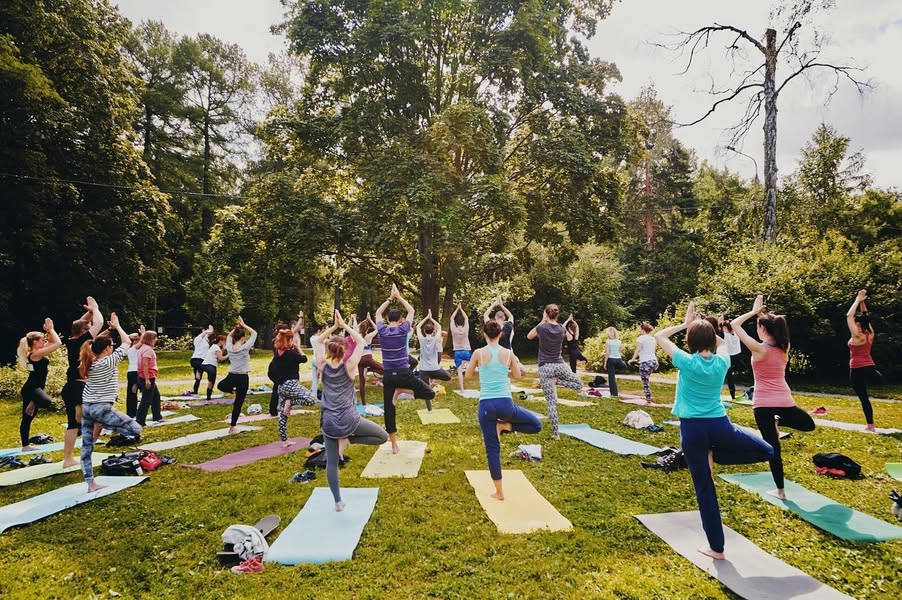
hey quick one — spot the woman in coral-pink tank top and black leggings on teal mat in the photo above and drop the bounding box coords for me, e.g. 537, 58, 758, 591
730, 296, 814, 500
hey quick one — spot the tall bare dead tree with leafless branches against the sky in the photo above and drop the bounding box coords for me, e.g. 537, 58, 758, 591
659, 0, 871, 243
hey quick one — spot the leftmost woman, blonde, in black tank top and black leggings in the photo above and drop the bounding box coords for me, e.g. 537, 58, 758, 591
16, 318, 63, 452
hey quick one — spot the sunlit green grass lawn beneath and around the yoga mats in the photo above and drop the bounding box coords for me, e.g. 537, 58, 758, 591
0, 352, 902, 598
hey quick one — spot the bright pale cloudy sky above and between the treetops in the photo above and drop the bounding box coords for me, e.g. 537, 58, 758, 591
118, 0, 902, 187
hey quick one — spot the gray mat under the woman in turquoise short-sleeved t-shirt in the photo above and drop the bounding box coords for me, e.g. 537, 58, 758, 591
635, 511, 851, 600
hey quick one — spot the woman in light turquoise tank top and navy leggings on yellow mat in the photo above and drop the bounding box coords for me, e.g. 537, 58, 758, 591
466, 320, 542, 500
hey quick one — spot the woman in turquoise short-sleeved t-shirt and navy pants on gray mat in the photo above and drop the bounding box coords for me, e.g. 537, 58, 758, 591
655, 302, 773, 560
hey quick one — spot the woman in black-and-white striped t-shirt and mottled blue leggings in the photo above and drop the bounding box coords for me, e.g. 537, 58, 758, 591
79, 313, 141, 492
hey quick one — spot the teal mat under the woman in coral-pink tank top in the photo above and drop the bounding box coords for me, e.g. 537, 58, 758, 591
720, 471, 902, 542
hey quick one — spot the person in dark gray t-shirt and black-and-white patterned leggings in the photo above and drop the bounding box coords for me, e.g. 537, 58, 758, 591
528, 304, 583, 440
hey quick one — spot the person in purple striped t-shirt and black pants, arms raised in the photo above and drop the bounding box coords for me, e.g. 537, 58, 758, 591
376, 284, 435, 454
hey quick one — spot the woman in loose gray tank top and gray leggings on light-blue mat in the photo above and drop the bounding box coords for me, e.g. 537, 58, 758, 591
317, 310, 388, 511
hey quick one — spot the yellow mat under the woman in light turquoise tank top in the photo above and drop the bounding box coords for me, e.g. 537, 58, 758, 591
464, 470, 573, 533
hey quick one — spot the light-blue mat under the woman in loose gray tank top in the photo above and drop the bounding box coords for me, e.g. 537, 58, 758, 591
266, 487, 379, 565
